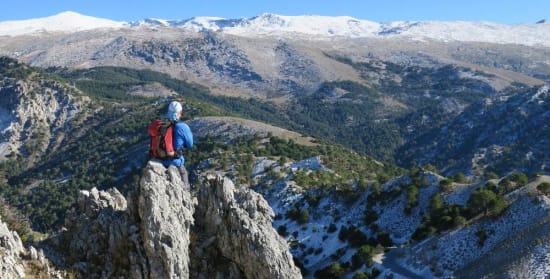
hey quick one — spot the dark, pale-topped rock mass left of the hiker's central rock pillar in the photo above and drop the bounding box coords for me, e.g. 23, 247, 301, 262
62, 188, 148, 278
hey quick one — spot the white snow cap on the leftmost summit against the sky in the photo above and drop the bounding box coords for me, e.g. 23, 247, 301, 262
0, 11, 127, 36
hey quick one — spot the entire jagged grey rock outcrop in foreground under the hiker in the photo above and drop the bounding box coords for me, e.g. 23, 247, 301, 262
58, 161, 301, 278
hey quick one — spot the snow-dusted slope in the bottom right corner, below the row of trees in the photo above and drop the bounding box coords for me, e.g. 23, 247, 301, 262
400, 191, 550, 278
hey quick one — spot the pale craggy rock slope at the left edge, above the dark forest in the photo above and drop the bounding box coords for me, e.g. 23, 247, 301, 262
0, 57, 90, 165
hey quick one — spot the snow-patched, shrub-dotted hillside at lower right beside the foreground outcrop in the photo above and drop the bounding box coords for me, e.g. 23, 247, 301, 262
184, 115, 550, 278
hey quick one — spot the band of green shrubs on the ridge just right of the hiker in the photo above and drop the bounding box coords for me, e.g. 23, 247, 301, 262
189, 133, 403, 192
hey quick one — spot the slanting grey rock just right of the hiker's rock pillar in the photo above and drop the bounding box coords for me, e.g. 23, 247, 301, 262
196, 177, 302, 278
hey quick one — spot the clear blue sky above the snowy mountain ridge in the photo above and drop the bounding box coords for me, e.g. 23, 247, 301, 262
0, 0, 550, 24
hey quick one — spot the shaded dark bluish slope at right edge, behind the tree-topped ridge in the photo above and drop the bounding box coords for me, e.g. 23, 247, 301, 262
399, 86, 550, 176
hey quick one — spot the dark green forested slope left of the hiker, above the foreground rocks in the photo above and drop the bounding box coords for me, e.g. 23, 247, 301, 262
0, 103, 155, 231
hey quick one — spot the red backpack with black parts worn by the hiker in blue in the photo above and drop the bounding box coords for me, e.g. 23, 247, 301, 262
147, 118, 176, 159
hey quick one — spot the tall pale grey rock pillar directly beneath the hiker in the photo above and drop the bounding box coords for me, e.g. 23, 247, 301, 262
138, 162, 193, 278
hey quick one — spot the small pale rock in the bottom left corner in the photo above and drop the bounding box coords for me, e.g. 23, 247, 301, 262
0, 219, 25, 278
